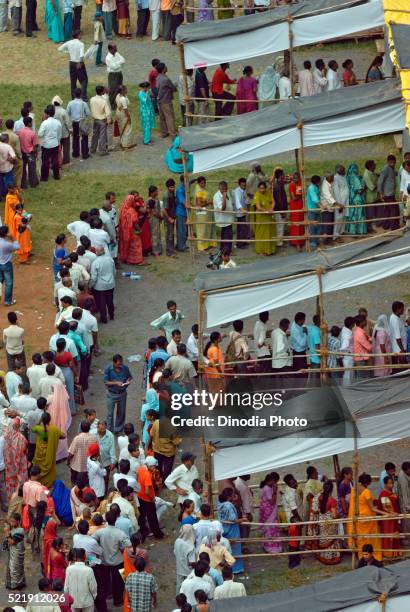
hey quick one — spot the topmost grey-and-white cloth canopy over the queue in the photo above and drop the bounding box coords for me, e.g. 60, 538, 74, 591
176, 0, 385, 68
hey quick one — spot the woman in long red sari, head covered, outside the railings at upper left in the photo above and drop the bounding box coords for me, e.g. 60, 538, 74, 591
119, 195, 144, 266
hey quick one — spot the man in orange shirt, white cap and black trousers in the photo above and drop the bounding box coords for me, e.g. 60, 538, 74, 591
138, 457, 165, 539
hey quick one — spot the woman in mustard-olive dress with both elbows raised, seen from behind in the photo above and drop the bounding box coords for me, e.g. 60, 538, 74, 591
32, 412, 66, 487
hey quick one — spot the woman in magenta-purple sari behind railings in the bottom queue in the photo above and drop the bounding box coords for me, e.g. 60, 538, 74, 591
259, 472, 282, 553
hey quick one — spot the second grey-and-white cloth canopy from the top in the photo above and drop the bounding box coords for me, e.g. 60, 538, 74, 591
180, 79, 406, 172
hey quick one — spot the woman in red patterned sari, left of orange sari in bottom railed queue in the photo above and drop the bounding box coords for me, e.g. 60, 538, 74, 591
316, 480, 341, 565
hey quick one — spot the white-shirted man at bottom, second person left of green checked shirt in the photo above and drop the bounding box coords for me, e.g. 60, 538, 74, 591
64, 548, 97, 612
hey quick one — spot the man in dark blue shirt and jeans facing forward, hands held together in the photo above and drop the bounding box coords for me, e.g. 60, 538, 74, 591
104, 354, 132, 433
